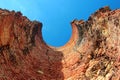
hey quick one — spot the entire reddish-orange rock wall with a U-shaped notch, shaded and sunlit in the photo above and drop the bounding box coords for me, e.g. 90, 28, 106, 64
0, 7, 120, 80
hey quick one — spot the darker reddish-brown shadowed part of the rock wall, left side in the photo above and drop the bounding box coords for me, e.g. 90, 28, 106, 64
0, 10, 64, 80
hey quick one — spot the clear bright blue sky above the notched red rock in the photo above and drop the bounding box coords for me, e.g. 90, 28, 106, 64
0, 0, 120, 47
